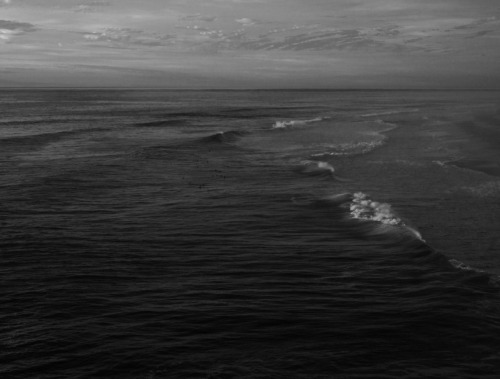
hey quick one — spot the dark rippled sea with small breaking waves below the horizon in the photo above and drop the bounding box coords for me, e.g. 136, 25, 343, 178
0, 90, 500, 379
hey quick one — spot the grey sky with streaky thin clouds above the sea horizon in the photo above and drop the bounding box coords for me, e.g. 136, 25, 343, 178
0, 0, 500, 89
